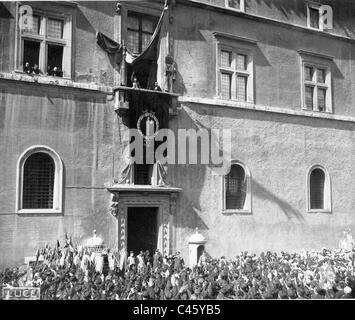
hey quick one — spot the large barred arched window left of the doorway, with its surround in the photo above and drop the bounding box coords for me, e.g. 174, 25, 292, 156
16, 146, 63, 213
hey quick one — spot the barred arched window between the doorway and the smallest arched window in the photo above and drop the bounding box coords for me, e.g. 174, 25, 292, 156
223, 162, 251, 212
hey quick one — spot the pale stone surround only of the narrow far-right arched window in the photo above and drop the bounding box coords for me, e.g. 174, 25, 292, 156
307, 164, 332, 213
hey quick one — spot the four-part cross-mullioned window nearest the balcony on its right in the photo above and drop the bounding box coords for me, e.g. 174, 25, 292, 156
219, 48, 253, 102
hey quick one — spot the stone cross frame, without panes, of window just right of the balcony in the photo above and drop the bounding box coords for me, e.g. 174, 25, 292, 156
216, 43, 254, 103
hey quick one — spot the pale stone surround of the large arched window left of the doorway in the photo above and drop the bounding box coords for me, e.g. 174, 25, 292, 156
15, 145, 63, 214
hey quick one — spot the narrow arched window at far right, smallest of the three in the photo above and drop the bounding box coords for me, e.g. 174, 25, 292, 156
308, 166, 331, 211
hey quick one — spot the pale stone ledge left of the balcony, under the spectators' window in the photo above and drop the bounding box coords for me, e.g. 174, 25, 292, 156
0, 72, 113, 94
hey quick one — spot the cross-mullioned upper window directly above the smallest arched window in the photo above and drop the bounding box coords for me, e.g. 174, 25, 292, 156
303, 63, 331, 112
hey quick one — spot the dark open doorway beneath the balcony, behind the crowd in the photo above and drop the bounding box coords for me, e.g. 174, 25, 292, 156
127, 207, 159, 255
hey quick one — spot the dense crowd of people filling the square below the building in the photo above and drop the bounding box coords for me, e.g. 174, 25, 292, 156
0, 238, 355, 300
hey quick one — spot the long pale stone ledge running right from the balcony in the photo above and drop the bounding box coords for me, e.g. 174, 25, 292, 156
178, 96, 355, 122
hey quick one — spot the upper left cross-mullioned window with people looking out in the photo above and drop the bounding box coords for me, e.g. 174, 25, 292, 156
17, 9, 72, 78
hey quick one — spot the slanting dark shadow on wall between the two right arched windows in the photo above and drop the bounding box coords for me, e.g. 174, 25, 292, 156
251, 179, 305, 223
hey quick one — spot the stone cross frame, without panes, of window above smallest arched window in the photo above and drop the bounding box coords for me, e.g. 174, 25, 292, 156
301, 57, 333, 113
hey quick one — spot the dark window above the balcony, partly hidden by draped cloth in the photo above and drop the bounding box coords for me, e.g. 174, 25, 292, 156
127, 12, 158, 54
